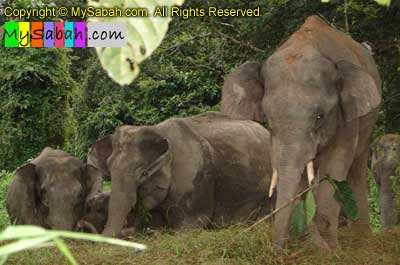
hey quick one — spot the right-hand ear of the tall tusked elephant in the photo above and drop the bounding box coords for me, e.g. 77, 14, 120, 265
337, 61, 381, 121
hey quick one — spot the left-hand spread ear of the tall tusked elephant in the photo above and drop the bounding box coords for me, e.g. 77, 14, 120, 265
221, 62, 265, 122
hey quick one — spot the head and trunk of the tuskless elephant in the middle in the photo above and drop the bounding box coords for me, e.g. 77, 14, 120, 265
88, 126, 171, 236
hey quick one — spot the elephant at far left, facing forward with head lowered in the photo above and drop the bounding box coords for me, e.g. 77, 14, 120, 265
6, 147, 102, 230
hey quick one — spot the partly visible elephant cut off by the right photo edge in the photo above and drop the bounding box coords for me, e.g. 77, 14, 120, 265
372, 134, 400, 231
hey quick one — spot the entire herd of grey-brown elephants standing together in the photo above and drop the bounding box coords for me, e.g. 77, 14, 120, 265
6, 16, 400, 248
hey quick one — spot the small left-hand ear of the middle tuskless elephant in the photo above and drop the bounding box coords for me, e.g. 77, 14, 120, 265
87, 135, 113, 176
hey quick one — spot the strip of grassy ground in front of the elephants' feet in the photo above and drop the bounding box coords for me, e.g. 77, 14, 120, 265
3, 224, 400, 265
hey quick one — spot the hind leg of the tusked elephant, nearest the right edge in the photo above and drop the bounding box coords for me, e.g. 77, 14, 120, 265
348, 152, 371, 232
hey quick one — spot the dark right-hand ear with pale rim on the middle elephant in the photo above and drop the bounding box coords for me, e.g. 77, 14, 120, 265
135, 129, 171, 186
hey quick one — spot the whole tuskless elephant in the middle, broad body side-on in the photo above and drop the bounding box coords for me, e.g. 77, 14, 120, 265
88, 112, 271, 236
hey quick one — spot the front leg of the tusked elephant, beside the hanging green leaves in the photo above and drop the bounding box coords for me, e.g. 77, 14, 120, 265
315, 181, 340, 248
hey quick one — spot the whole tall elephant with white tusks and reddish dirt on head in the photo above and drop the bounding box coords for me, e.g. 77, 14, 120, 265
221, 16, 381, 248
